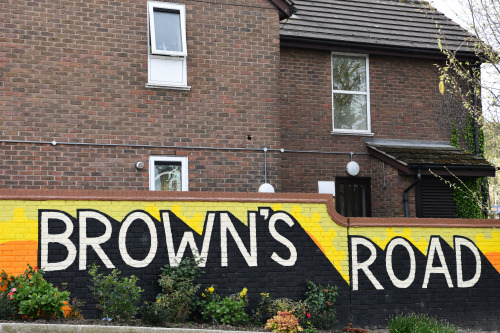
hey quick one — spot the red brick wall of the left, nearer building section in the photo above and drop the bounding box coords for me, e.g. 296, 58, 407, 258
0, 0, 281, 191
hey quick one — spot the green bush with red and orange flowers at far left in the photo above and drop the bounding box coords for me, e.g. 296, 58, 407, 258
0, 265, 69, 319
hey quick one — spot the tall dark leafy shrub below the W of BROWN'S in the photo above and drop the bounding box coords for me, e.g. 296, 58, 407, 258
157, 258, 201, 323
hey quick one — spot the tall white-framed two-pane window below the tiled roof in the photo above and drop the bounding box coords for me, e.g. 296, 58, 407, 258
332, 53, 373, 135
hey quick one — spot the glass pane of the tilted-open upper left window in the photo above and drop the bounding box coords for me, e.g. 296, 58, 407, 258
154, 9, 182, 52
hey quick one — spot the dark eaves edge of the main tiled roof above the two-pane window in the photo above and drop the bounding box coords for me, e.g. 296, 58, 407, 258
280, 35, 480, 62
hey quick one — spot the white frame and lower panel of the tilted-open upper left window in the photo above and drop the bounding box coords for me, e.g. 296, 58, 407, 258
146, 1, 191, 90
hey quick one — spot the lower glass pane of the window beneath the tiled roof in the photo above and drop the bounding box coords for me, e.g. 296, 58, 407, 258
333, 94, 368, 131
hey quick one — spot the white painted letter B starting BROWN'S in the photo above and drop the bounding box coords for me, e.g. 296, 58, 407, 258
40, 211, 77, 272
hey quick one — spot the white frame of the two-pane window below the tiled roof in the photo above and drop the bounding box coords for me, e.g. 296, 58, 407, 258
330, 52, 374, 136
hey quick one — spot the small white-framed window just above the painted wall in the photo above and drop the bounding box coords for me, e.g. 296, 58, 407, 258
149, 156, 189, 191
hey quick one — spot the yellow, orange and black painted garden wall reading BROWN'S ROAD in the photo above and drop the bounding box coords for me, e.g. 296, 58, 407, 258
0, 190, 500, 328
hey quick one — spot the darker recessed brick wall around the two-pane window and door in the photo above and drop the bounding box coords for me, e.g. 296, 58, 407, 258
280, 48, 450, 216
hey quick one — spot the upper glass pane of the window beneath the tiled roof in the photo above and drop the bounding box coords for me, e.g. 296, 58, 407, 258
332, 55, 366, 92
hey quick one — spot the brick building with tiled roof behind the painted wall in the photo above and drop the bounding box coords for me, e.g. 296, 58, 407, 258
0, 0, 494, 216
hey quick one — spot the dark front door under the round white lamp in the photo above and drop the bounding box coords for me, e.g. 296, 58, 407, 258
335, 177, 372, 217
